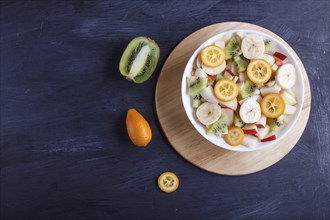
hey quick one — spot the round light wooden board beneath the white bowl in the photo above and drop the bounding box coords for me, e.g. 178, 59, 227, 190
155, 22, 311, 175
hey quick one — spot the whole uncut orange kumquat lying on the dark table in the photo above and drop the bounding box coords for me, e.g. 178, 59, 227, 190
126, 109, 152, 147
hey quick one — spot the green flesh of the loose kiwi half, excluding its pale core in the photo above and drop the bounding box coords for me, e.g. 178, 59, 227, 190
119, 36, 160, 83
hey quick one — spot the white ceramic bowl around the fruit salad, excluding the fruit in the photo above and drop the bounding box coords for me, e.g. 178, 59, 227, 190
181, 29, 305, 151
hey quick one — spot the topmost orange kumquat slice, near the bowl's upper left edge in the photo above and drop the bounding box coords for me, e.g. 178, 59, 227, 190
201, 46, 226, 68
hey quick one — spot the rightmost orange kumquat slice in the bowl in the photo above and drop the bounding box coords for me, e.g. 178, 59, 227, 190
260, 93, 285, 118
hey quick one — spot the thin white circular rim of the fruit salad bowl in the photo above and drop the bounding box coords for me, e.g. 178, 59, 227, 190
181, 28, 305, 152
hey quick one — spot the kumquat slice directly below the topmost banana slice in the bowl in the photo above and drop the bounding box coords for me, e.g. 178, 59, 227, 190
246, 59, 272, 84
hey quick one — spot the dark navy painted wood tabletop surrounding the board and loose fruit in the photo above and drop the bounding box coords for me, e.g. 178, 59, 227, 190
0, 0, 330, 219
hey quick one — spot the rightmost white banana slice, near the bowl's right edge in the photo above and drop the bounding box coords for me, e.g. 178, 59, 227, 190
275, 64, 297, 89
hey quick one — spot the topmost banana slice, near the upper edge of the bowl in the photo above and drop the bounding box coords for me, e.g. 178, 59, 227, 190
241, 34, 265, 60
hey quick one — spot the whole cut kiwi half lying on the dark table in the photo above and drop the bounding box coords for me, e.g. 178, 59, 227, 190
119, 36, 160, 83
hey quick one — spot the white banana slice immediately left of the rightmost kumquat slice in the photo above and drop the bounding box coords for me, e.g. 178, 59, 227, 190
239, 98, 261, 123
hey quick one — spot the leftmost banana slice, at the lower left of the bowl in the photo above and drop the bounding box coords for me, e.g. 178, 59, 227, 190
196, 102, 221, 126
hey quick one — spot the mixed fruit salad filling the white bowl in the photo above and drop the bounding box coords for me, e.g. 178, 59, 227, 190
188, 32, 297, 147
